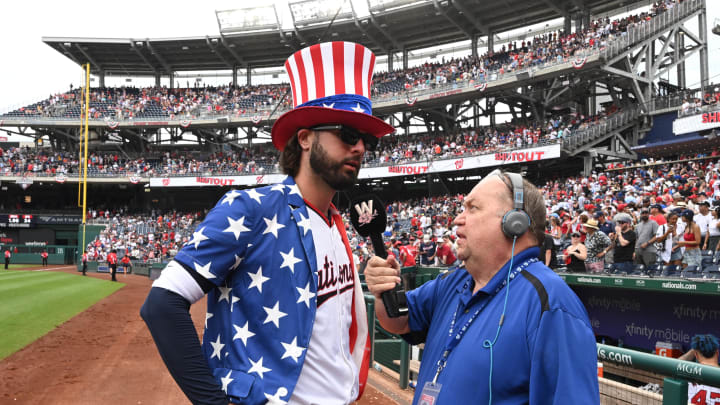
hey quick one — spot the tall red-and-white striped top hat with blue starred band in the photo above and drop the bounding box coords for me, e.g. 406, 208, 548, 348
271, 42, 395, 150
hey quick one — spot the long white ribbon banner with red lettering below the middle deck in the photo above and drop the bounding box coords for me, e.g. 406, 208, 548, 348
150, 144, 560, 187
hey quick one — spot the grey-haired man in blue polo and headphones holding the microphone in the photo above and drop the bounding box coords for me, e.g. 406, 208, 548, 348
365, 171, 600, 405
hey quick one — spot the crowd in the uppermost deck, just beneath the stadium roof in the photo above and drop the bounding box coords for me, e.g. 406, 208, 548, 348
0, 0, 682, 121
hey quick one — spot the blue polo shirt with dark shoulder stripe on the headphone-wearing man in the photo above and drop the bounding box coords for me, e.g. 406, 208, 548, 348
406, 247, 600, 404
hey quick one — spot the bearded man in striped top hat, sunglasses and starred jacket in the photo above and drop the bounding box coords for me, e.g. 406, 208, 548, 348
140, 42, 394, 404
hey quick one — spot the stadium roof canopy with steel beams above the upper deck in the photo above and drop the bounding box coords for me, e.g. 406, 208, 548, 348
43, 0, 650, 76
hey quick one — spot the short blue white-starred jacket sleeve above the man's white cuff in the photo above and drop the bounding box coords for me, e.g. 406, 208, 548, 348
175, 189, 260, 286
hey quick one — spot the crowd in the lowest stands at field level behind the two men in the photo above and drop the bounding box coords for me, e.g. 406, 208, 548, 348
83, 150, 720, 280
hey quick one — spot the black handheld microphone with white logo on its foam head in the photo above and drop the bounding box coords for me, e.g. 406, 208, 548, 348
350, 195, 408, 318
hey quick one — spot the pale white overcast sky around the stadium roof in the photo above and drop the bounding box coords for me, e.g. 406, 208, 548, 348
0, 0, 720, 112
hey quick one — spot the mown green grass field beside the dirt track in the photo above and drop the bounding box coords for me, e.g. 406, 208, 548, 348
0, 266, 124, 360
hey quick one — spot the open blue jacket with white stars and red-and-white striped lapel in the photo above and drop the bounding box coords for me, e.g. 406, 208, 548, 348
175, 177, 370, 404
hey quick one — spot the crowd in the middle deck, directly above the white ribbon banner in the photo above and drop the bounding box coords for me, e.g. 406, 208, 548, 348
0, 106, 617, 177
